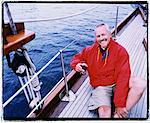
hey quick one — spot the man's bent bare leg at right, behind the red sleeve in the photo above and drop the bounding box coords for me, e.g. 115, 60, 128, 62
114, 77, 147, 118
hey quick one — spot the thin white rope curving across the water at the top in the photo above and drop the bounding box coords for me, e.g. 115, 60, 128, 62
6, 5, 98, 23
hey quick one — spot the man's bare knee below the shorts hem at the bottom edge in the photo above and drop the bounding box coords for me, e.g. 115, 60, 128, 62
98, 106, 111, 118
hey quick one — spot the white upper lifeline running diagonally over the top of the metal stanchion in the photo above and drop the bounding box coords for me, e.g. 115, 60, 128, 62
3, 40, 76, 108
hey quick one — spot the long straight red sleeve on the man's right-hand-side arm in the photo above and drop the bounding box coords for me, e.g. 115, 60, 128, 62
114, 48, 131, 107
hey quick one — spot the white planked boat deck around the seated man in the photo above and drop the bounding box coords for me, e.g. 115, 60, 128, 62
59, 15, 147, 118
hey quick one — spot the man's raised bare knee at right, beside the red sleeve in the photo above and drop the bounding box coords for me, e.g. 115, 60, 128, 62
129, 77, 147, 93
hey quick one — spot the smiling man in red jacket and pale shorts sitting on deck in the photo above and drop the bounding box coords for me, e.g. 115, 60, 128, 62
70, 24, 146, 118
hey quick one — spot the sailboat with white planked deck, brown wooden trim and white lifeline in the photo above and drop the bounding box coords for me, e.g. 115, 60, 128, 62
3, 2, 148, 119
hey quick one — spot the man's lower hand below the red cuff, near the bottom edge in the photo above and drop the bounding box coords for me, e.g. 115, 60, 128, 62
115, 107, 128, 118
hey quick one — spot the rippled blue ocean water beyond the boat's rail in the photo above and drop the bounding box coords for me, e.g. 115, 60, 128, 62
2, 3, 133, 119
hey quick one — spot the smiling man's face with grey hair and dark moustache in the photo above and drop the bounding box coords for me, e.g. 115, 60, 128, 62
95, 26, 111, 48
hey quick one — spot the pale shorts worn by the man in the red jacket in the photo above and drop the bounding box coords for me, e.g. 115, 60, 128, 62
88, 84, 115, 110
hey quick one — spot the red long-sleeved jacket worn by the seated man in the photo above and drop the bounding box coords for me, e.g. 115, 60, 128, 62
70, 39, 131, 107
